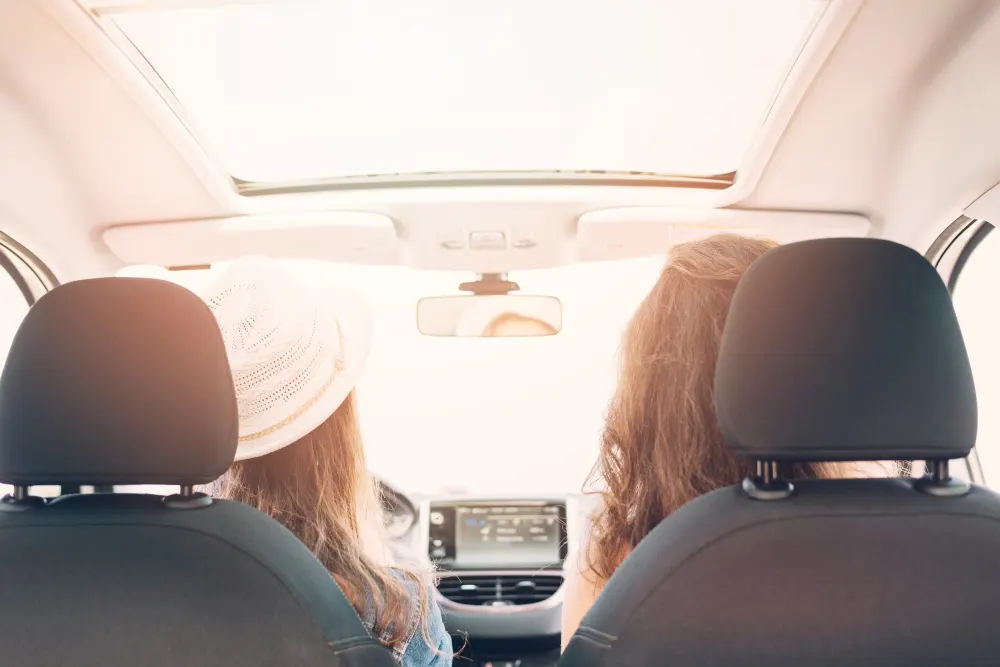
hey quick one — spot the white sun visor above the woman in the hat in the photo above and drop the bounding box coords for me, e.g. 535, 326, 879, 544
103, 211, 399, 267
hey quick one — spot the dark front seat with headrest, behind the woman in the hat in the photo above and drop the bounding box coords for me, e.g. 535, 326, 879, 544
0, 278, 394, 667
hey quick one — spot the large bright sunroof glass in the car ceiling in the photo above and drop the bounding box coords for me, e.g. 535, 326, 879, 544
101, 0, 827, 182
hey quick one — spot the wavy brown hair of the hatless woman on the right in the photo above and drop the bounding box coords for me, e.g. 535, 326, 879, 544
586, 234, 864, 581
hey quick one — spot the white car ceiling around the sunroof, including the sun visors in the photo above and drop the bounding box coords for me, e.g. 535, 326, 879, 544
0, 0, 1000, 280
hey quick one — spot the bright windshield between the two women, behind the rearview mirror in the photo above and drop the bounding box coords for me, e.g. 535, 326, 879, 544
120, 257, 664, 494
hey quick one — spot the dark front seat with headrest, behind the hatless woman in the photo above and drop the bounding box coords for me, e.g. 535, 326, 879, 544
562, 239, 1000, 667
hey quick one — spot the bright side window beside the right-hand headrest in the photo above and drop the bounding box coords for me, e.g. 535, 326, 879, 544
953, 230, 1000, 489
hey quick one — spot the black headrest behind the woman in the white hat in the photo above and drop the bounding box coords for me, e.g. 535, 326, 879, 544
0, 278, 238, 485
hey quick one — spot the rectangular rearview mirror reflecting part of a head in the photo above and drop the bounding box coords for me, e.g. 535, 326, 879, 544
417, 294, 562, 338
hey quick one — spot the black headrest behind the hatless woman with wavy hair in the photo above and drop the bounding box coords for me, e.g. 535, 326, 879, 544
715, 238, 977, 461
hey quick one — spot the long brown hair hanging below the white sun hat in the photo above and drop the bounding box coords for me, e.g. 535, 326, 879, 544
215, 392, 437, 650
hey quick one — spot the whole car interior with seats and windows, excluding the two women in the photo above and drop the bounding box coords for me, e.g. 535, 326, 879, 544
0, 0, 1000, 667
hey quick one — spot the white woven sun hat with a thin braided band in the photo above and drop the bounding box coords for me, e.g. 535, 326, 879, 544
202, 256, 373, 461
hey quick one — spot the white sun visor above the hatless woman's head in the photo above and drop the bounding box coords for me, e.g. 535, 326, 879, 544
577, 206, 871, 261
